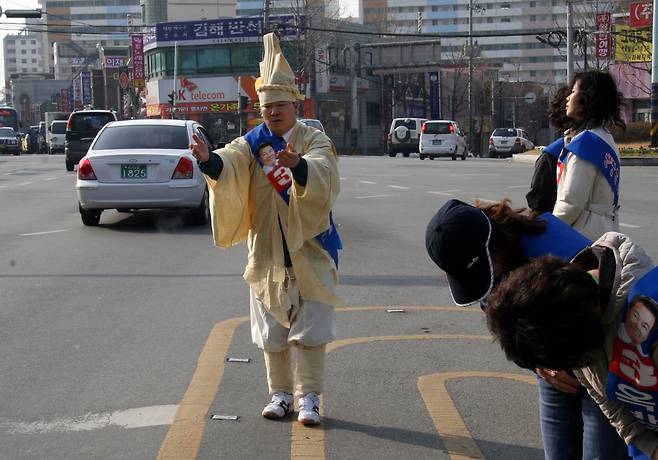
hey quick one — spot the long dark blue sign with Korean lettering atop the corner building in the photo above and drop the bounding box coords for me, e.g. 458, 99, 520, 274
144, 15, 305, 51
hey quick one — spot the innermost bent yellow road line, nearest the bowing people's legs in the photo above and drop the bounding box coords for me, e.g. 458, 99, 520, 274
418, 371, 537, 460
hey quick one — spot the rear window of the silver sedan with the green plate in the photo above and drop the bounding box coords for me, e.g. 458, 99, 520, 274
93, 125, 190, 150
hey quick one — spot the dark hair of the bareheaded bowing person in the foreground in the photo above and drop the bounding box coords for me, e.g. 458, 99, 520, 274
485, 257, 604, 370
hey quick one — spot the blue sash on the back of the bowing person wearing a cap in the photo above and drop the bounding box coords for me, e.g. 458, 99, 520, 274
519, 212, 592, 261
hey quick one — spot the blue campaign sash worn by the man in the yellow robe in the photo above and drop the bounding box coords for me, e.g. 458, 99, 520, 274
244, 123, 343, 267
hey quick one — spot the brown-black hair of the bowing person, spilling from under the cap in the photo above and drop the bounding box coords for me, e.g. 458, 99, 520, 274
475, 198, 546, 273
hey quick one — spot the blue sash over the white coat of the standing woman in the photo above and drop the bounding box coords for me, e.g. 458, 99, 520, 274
558, 131, 621, 206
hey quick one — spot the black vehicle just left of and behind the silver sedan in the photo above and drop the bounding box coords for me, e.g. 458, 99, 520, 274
64, 110, 117, 171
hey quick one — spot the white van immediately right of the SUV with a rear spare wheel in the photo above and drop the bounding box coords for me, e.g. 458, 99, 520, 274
419, 120, 468, 160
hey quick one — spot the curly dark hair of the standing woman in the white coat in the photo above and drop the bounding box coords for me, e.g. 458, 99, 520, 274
570, 70, 626, 131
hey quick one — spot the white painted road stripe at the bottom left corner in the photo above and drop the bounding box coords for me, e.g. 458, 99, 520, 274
0, 404, 178, 434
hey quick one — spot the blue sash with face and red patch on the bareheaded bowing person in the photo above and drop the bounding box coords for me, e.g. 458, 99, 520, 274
605, 267, 658, 430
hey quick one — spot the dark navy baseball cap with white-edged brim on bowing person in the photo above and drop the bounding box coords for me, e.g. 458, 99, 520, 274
425, 200, 494, 306
